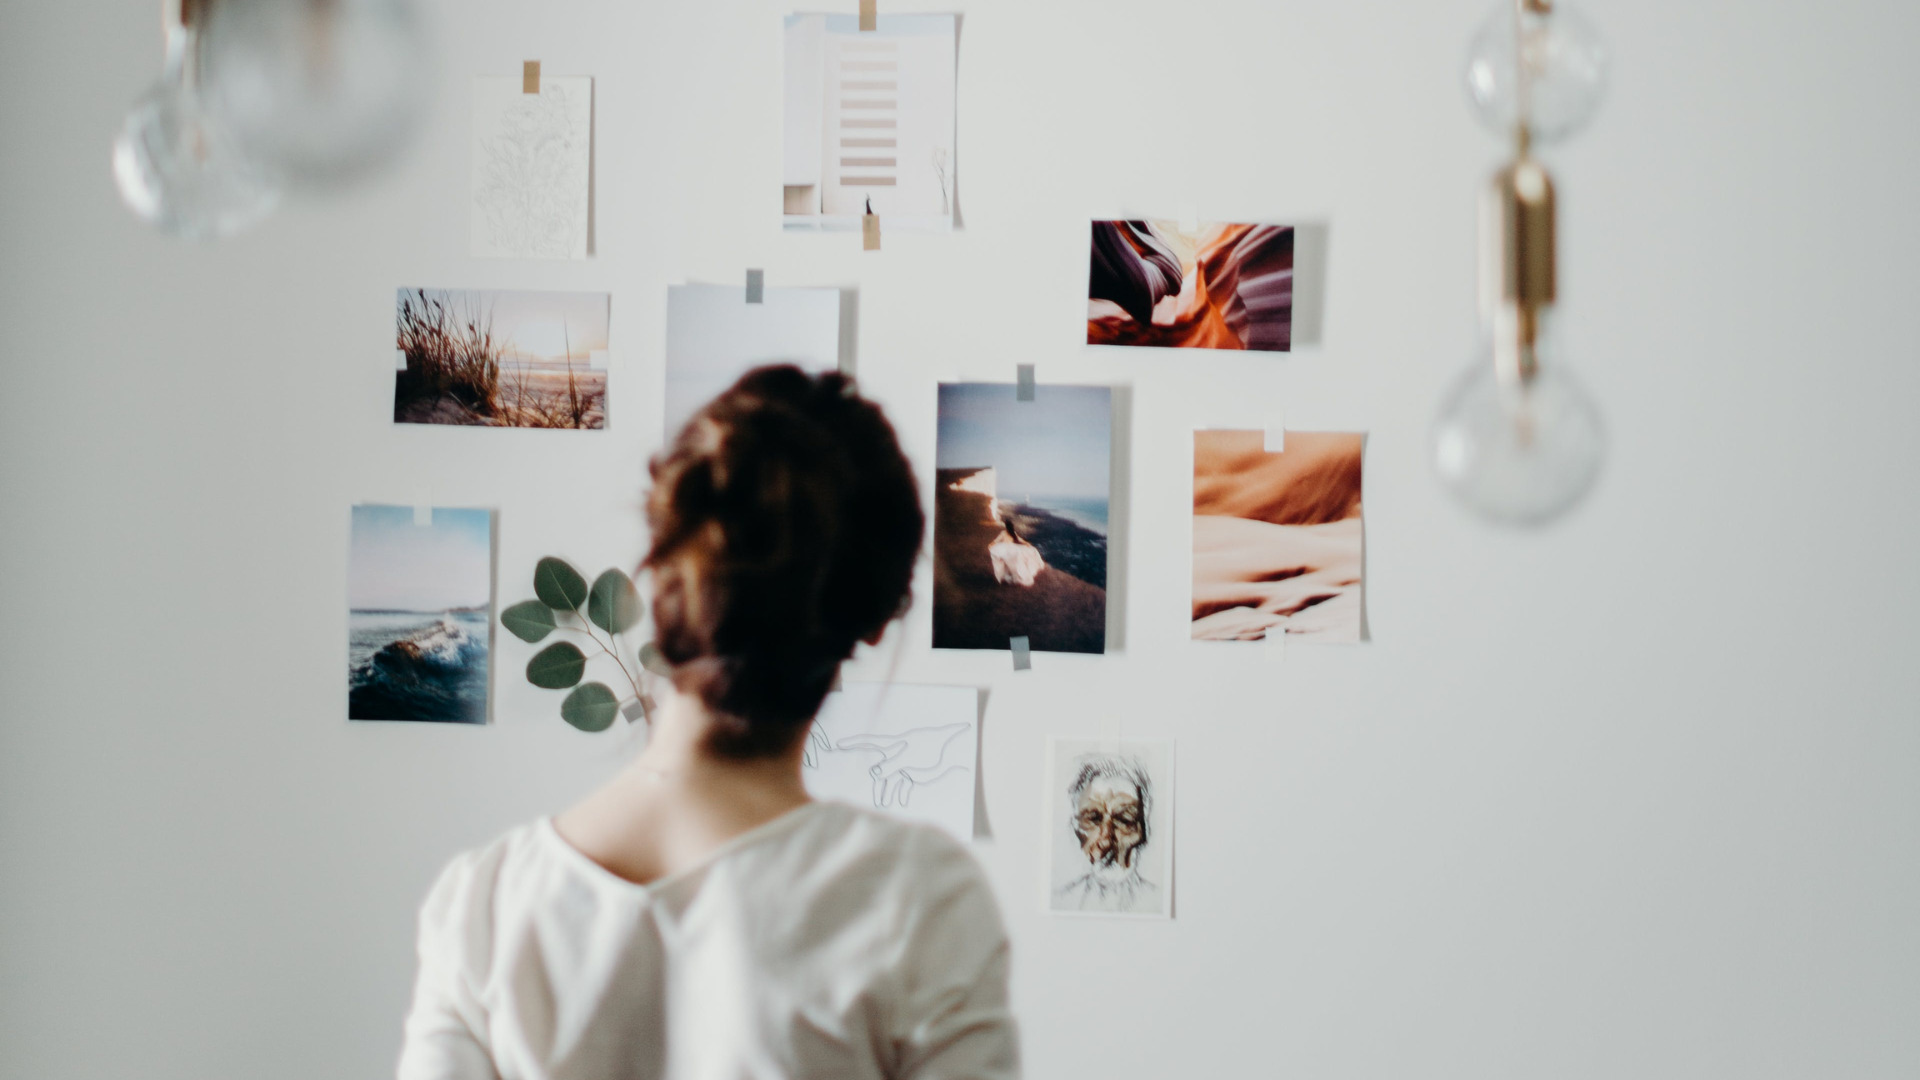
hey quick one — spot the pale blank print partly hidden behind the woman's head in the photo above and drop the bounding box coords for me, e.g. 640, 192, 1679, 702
660, 284, 839, 440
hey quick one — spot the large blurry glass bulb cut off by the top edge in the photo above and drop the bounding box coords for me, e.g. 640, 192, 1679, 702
205, 0, 432, 188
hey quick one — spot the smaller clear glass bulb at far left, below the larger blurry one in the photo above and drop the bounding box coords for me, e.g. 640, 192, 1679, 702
113, 29, 280, 240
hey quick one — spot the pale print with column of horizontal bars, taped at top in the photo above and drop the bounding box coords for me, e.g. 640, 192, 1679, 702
783, 15, 956, 231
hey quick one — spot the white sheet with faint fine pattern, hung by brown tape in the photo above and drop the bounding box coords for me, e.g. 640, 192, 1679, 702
470, 77, 593, 259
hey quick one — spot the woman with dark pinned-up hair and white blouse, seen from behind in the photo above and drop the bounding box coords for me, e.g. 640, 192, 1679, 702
399, 367, 1018, 1080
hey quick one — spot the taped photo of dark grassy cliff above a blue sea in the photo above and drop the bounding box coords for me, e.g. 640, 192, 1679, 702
933, 382, 1114, 653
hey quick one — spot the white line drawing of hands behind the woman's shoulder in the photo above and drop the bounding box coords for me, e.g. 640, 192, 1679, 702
803, 682, 979, 842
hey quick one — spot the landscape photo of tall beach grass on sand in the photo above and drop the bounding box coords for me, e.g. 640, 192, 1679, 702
394, 288, 609, 430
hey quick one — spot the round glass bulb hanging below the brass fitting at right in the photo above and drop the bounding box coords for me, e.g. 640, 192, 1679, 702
1432, 330, 1607, 525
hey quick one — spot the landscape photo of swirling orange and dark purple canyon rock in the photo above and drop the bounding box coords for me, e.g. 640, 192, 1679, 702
1087, 221, 1294, 352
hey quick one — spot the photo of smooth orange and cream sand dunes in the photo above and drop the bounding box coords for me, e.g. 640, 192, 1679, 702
1192, 430, 1367, 642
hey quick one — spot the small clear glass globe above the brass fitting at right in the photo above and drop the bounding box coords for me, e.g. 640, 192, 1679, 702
1467, 0, 1607, 142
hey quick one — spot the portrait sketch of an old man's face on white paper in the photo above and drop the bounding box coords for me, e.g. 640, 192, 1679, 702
1046, 738, 1173, 919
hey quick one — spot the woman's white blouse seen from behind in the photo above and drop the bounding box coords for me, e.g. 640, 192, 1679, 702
399, 803, 1020, 1080
